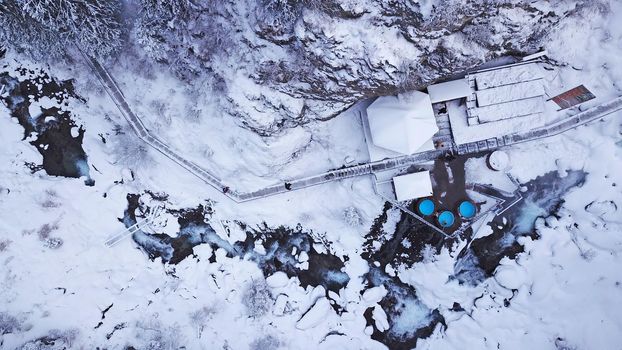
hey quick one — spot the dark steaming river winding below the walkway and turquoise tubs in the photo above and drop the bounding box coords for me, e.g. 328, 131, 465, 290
122, 152, 586, 349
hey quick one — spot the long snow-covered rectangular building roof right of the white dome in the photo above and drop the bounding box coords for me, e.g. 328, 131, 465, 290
428, 61, 553, 145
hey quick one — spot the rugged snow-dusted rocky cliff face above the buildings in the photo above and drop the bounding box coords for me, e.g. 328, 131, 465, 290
135, 0, 589, 135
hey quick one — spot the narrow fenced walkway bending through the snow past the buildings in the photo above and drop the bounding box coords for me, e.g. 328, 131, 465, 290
84, 55, 622, 202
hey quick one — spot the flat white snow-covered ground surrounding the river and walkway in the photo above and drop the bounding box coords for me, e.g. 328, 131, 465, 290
0, 2, 622, 349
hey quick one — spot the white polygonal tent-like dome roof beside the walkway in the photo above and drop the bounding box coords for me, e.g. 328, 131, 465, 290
367, 91, 438, 154
